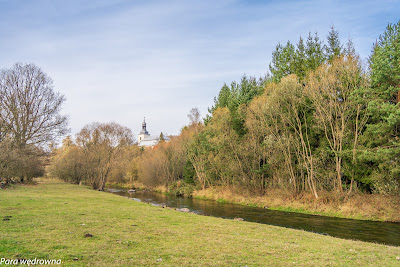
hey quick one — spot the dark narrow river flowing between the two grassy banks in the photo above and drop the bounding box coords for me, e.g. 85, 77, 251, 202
109, 189, 400, 246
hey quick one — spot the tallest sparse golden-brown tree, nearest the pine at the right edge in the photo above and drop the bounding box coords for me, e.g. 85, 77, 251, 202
305, 56, 366, 195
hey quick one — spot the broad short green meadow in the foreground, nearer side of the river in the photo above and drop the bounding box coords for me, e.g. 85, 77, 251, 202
0, 180, 400, 266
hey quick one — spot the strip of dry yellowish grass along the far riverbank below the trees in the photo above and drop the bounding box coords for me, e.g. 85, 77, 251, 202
193, 187, 400, 222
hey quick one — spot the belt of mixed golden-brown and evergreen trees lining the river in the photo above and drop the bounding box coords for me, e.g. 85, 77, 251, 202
0, 22, 400, 199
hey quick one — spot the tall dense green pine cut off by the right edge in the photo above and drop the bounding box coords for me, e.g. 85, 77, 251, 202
361, 21, 400, 194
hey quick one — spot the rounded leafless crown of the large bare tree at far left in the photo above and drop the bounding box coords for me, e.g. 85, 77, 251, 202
0, 63, 68, 147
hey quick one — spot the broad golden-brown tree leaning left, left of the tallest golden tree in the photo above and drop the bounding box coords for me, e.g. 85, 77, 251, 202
247, 75, 318, 199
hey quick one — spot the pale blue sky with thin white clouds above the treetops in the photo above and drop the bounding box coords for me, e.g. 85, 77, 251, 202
0, 0, 400, 140
